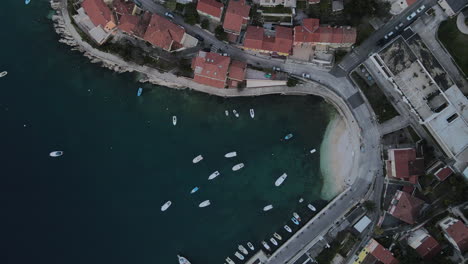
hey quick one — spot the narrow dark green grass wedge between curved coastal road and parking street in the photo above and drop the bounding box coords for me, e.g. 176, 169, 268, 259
351, 72, 398, 123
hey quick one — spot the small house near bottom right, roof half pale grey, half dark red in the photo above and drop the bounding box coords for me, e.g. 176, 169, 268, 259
408, 228, 441, 259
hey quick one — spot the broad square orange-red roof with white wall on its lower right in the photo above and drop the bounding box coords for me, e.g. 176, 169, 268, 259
143, 14, 185, 51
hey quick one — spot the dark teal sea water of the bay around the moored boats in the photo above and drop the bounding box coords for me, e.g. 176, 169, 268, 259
0, 0, 336, 264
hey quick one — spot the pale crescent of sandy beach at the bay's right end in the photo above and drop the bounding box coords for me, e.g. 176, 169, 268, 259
320, 114, 356, 200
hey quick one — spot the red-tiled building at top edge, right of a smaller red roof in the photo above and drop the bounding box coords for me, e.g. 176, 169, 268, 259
223, 0, 250, 35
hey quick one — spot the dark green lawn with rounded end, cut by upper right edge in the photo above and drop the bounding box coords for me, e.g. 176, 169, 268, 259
437, 17, 468, 75
